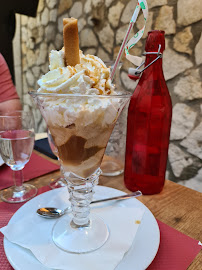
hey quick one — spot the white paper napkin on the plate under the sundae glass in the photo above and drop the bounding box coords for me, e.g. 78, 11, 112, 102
0, 189, 144, 270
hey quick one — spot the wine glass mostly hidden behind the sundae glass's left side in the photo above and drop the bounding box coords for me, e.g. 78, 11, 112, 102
47, 129, 67, 189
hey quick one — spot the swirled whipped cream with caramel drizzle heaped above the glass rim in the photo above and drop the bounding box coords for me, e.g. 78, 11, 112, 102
38, 50, 115, 95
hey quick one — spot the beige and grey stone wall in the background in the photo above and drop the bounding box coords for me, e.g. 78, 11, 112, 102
18, 0, 202, 191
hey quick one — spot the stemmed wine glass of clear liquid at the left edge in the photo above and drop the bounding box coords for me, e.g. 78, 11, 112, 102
0, 111, 37, 203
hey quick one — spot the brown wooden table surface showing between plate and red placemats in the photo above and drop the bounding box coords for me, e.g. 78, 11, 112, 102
1, 152, 202, 270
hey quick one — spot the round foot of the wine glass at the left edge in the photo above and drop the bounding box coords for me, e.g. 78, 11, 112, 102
0, 184, 37, 203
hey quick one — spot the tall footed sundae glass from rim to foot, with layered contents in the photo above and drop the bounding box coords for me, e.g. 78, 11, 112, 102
30, 92, 130, 253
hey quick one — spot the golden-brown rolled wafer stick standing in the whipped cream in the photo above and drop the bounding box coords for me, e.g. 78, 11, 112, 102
63, 18, 80, 66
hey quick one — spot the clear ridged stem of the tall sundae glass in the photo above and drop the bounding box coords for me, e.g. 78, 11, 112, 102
67, 169, 101, 228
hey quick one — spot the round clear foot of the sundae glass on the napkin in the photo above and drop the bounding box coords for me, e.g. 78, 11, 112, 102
52, 215, 109, 253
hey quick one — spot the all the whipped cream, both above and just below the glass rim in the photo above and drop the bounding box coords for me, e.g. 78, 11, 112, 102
38, 49, 118, 127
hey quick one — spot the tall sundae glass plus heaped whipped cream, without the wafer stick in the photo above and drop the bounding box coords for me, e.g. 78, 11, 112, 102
30, 18, 130, 253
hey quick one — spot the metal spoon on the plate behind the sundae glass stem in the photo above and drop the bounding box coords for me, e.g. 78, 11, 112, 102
36, 190, 142, 218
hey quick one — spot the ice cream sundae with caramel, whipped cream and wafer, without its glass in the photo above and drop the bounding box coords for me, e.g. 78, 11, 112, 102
37, 18, 120, 178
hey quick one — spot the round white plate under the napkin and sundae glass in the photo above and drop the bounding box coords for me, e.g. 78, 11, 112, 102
4, 186, 160, 270
